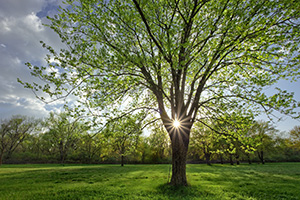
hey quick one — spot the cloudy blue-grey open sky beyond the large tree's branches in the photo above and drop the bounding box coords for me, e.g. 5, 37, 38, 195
0, 0, 300, 134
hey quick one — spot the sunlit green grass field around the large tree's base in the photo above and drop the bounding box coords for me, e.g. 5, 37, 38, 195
0, 163, 300, 200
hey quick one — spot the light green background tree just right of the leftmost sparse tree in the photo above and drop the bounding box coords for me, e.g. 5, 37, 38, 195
43, 112, 88, 163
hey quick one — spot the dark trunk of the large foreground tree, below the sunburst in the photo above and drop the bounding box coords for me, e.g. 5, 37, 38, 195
170, 128, 190, 186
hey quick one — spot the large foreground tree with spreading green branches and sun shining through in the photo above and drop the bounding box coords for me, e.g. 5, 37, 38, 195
19, 0, 300, 185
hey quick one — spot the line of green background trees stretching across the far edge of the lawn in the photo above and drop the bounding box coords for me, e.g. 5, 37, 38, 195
0, 113, 300, 165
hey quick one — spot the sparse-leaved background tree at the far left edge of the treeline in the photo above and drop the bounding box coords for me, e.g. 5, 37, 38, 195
0, 115, 37, 165
